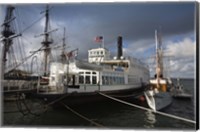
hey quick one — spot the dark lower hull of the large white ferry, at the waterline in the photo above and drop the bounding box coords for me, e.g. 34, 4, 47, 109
34, 87, 145, 105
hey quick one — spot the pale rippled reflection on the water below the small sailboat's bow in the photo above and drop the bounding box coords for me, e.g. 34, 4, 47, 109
144, 110, 156, 128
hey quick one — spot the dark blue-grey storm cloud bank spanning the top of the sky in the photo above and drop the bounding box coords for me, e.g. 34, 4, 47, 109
0, 2, 195, 43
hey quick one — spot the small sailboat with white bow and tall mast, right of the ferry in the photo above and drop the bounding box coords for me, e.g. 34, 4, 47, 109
144, 30, 172, 111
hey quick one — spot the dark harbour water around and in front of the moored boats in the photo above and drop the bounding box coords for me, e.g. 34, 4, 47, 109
3, 79, 195, 130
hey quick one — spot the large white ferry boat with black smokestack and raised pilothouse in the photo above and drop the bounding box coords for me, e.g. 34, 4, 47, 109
38, 36, 150, 103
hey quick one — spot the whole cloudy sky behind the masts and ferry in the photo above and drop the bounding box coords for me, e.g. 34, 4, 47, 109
0, 2, 196, 78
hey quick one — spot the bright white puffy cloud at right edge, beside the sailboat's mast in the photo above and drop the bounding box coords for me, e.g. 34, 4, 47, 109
166, 38, 196, 78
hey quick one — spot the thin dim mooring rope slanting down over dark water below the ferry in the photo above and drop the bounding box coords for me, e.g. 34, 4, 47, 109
61, 102, 104, 127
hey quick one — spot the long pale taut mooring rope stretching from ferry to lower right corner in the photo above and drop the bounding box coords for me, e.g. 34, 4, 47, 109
98, 92, 196, 124
